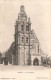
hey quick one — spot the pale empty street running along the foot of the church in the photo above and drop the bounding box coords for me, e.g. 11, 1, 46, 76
0, 64, 51, 71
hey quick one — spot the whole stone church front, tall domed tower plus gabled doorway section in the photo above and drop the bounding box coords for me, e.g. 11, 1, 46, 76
12, 5, 41, 66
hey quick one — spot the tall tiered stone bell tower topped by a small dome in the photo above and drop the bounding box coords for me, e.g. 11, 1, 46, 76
15, 5, 31, 65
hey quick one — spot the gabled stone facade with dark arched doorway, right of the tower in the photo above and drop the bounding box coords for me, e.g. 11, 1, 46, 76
30, 30, 42, 65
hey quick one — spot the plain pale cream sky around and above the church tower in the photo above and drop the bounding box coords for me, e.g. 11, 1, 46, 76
0, 0, 51, 56
